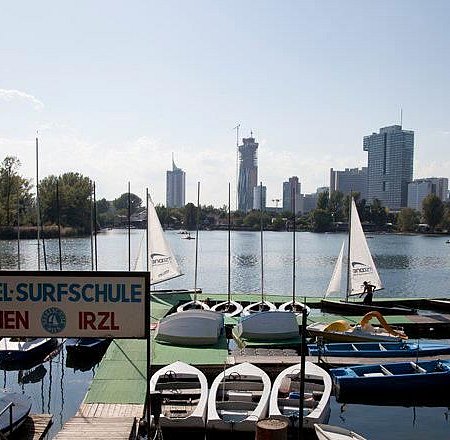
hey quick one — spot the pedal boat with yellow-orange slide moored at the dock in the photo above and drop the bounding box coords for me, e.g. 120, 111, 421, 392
306, 312, 408, 342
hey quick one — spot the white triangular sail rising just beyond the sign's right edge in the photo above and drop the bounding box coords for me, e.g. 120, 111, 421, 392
147, 195, 182, 284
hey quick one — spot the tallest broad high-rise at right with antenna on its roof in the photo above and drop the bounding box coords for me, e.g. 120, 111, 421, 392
363, 125, 414, 211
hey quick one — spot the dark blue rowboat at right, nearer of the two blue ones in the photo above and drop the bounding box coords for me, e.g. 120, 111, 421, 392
330, 360, 450, 406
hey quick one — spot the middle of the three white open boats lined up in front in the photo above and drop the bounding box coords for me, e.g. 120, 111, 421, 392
207, 362, 270, 432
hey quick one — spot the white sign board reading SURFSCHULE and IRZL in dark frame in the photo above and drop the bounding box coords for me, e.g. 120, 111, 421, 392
0, 271, 150, 338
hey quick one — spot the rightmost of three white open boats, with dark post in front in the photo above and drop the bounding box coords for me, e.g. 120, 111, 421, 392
269, 361, 332, 429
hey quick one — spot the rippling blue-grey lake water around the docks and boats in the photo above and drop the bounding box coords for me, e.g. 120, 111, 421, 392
0, 230, 450, 440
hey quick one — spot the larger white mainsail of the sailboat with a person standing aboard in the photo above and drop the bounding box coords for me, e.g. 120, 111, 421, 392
348, 198, 383, 295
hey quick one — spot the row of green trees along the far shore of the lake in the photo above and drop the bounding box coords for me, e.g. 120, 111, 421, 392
0, 156, 450, 237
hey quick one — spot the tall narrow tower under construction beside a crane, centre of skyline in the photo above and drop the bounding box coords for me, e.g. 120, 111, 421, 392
238, 133, 258, 212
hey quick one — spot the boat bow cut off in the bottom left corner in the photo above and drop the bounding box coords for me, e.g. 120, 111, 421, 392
0, 390, 31, 438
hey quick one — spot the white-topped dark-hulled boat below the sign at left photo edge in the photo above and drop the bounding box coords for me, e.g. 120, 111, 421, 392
0, 338, 59, 367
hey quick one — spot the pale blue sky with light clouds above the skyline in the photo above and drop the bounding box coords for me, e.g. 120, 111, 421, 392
0, 0, 450, 207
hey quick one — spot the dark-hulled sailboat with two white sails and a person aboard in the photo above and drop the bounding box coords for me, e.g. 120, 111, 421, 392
321, 197, 417, 315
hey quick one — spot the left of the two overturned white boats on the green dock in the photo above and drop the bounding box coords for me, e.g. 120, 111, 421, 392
155, 310, 224, 346
